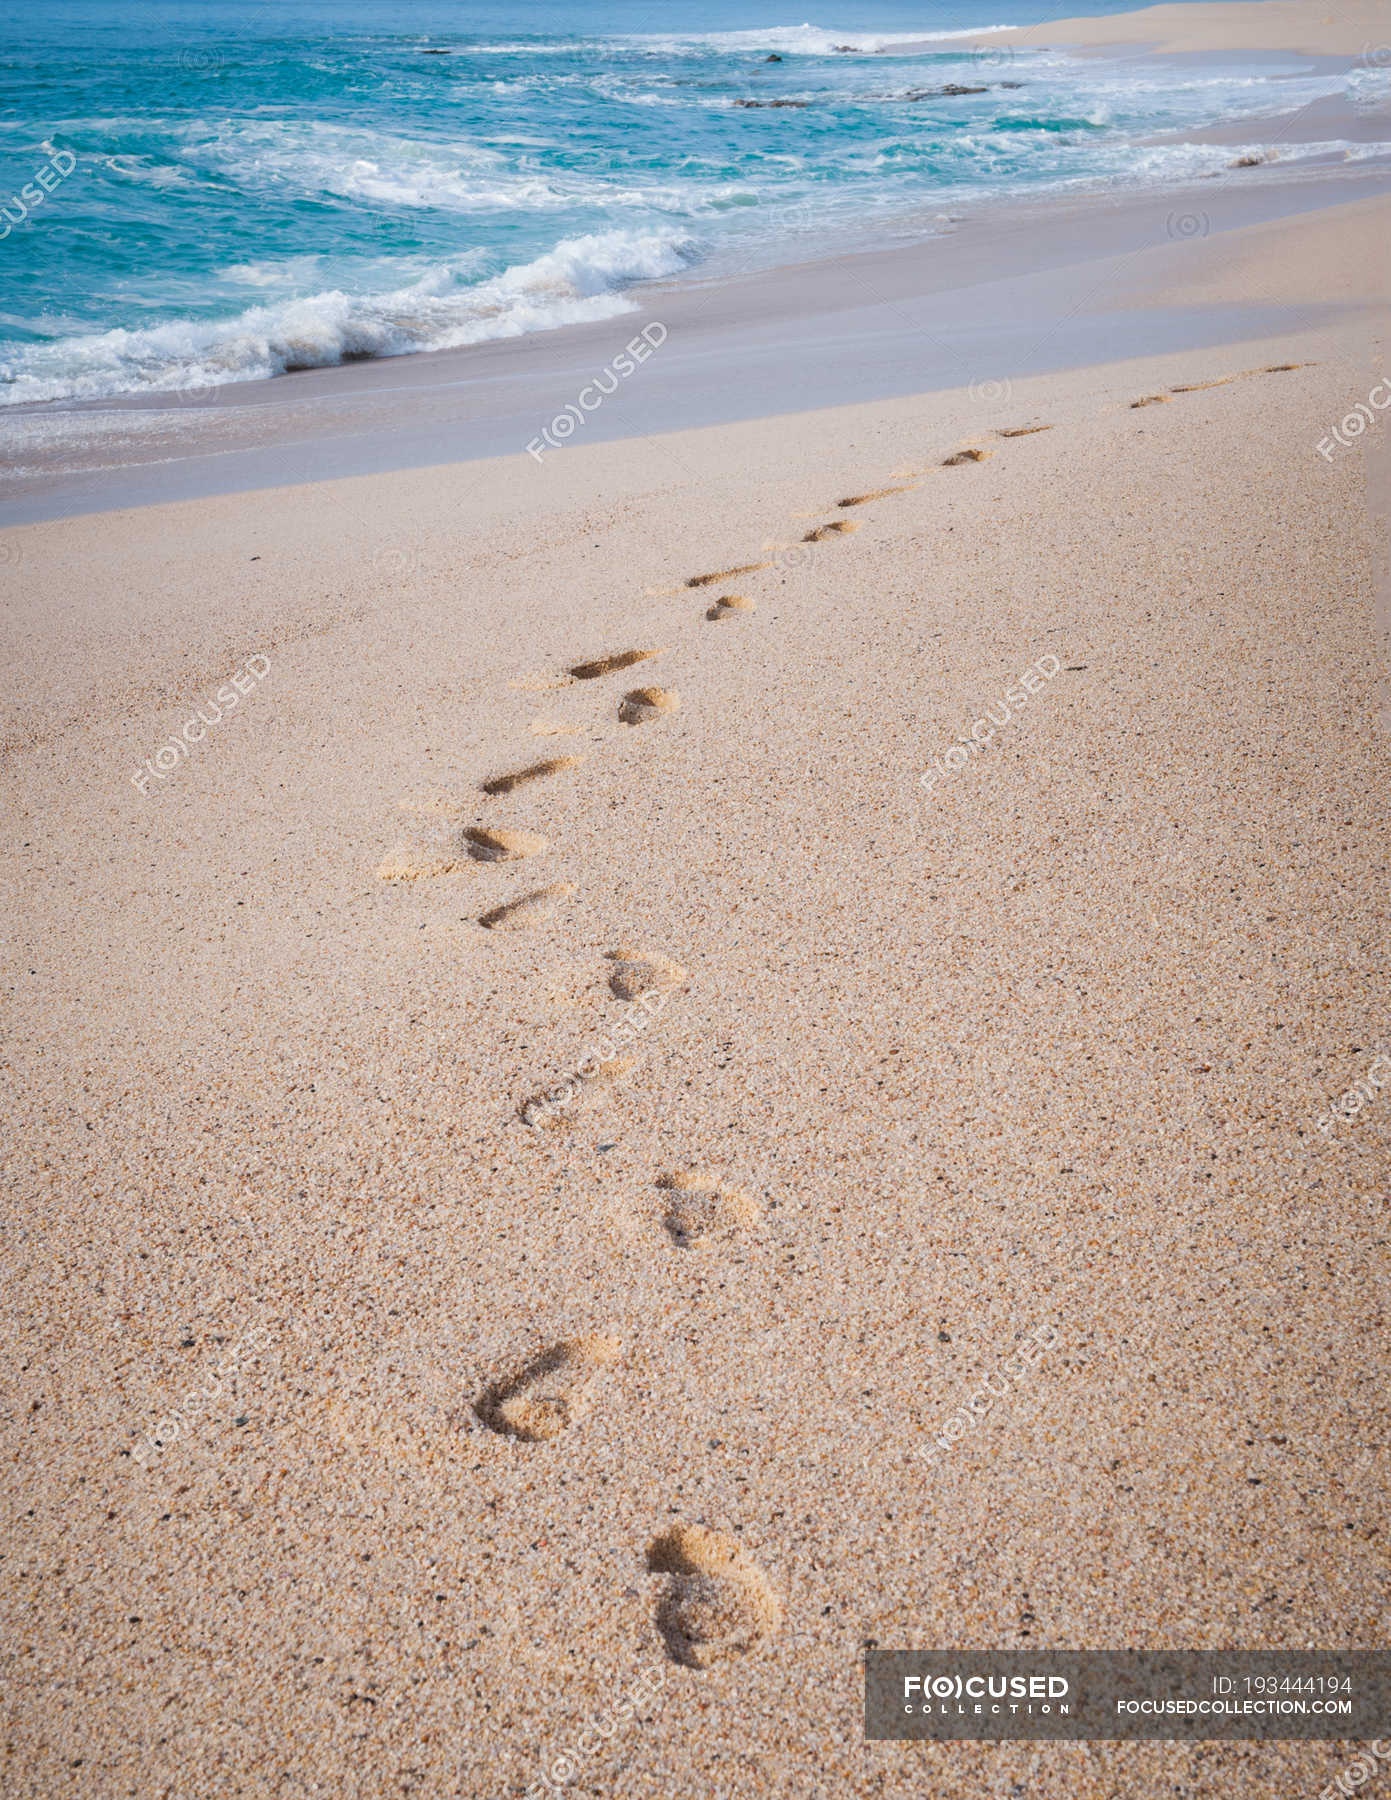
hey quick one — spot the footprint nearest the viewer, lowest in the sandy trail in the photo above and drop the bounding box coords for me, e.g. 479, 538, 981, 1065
648, 1525, 783, 1669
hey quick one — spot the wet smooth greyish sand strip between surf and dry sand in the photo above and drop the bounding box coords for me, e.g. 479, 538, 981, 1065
0, 10, 1391, 527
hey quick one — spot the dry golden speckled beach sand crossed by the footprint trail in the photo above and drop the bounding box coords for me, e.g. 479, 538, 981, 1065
0, 4, 1391, 1800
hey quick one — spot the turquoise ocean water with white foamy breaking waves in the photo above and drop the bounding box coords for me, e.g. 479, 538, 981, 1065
0, 0, 1387, 403
